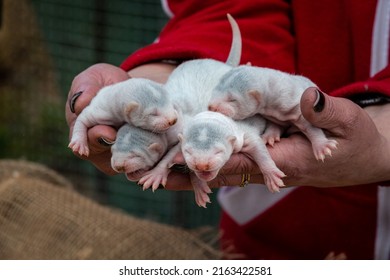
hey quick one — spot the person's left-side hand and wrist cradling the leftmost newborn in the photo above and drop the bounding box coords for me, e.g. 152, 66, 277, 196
65, 63, 174, 175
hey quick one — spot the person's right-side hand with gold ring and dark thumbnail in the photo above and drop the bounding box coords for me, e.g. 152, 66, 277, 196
166, 88, 390, 189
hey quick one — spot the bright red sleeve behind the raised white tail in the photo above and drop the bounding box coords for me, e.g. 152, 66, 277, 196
121, 0, 295, 72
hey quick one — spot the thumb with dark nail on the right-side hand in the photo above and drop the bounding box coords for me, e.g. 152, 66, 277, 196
300, 87, 361, 135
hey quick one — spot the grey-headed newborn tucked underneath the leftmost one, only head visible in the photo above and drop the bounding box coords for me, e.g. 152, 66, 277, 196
111, 124, 168, 181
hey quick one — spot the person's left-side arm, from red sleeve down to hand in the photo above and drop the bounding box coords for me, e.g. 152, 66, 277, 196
65, 0, 294, 174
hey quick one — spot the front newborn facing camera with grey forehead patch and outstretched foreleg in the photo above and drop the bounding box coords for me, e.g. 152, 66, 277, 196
179, 111, 285, 207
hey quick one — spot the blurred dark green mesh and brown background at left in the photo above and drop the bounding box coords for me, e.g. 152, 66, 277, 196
0, 0, 219, 229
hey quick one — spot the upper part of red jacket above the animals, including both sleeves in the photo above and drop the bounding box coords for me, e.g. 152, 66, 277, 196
121, 0, 390, 96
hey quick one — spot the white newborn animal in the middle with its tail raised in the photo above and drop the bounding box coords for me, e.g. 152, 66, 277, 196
138, 15, 242, 197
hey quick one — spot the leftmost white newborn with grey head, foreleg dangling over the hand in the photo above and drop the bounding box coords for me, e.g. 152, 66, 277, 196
69, 78, 177, 156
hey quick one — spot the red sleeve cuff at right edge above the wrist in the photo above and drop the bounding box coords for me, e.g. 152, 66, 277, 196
330, 66, 390, 98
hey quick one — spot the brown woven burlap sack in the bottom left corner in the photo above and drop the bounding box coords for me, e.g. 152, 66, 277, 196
0, 161, 221, 259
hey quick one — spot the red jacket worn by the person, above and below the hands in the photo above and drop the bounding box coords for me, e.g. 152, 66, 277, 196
122, 0, 390, 259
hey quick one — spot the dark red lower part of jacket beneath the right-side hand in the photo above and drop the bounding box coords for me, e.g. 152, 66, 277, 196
221, 186, 377, 259
